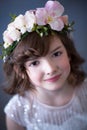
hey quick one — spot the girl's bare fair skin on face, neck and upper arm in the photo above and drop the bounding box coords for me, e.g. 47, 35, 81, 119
6, 37, 74, 130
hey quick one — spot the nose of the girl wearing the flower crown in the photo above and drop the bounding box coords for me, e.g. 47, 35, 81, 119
44, 59, 57, 75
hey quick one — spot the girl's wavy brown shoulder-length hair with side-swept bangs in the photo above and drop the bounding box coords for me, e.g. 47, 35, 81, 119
3, 31, 86, 94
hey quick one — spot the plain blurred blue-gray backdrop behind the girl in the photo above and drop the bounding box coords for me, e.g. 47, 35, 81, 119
0, 0, 87, 130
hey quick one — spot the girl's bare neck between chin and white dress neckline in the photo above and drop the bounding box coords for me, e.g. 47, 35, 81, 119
36, 85, 74, 106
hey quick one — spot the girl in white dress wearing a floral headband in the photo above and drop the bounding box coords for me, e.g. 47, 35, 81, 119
3, 1, 87, 130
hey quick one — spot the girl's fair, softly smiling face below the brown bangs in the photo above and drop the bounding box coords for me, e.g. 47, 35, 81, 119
25, 37, 70, 91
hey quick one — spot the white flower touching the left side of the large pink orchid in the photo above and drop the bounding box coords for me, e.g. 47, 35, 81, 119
25, 11, 36, 32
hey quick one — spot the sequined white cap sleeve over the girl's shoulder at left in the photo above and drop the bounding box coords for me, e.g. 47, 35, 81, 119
4, 94, 30, 126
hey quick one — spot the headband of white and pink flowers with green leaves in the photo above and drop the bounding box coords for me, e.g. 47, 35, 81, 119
2, 0, 72, 61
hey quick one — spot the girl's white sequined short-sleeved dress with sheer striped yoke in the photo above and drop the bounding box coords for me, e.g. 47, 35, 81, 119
4, 80, 87, 130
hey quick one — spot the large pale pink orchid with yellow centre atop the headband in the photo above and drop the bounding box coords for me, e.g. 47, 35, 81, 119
36, 0, 64, 31
